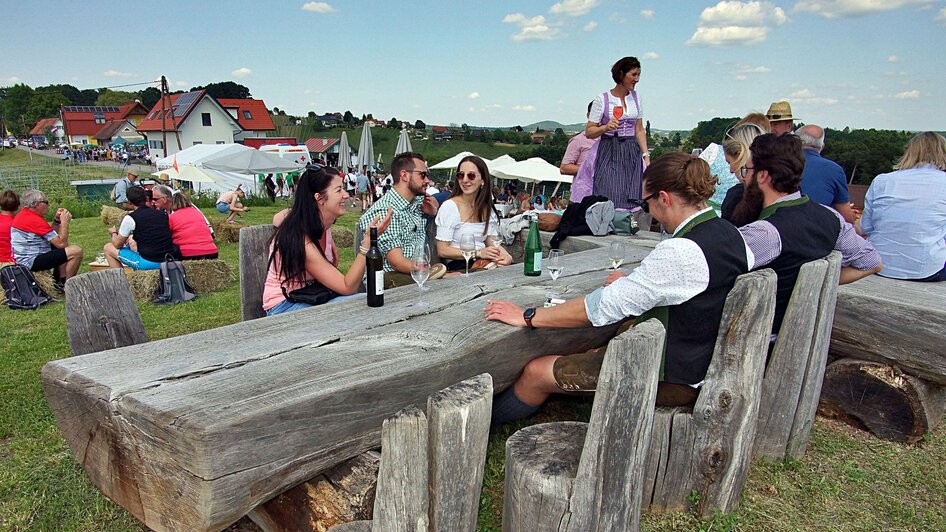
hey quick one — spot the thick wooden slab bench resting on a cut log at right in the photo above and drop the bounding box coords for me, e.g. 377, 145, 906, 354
821, 275, 946, 443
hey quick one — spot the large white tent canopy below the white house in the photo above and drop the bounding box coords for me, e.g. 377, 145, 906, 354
157, 144, 304, 193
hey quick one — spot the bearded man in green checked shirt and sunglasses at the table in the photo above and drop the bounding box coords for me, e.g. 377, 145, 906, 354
358, 152, 446, 288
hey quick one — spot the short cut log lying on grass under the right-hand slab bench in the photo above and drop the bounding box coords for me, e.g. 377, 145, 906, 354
820, 358, 946, 443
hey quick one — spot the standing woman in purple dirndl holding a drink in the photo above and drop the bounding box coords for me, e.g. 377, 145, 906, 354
585, 57, 650, 210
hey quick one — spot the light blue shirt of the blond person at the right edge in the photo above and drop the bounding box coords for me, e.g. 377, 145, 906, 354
861, 164, 946, 279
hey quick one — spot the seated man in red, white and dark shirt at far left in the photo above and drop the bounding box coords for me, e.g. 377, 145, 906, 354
10, 190, 82, 288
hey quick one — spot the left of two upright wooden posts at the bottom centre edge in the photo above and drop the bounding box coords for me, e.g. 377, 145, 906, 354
371, 406, 430, 532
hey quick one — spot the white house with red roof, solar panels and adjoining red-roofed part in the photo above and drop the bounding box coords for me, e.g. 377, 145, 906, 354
138, 90, 276, 159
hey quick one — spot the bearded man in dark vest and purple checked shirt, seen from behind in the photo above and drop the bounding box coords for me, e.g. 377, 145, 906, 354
733, 133, 882, 334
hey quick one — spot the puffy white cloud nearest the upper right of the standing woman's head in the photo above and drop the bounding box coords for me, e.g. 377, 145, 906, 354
687, 0, 788, 46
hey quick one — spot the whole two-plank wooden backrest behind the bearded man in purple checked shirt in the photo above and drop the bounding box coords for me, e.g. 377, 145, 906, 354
753, 251, 841, 460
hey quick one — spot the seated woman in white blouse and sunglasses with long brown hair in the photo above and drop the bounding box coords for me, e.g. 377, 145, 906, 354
436, 155, 512, 271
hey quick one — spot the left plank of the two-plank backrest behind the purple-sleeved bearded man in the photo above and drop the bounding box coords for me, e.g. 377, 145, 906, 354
753, 259, 828, 460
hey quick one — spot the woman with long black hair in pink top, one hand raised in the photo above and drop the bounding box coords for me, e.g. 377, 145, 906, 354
263, 165, 391, 316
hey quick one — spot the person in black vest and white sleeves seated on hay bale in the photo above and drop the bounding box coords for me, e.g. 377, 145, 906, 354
103, 187, 181, 270
